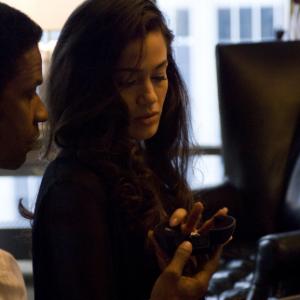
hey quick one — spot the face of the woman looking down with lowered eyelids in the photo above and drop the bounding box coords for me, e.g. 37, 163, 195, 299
116, 31, 168, 140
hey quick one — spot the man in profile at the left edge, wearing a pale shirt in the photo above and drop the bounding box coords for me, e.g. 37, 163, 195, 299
0, 2, 47, 300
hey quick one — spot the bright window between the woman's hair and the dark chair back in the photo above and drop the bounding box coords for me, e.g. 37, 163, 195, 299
156, 0, 290, 188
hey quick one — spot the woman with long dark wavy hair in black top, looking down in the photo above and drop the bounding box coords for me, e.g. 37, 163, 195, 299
33, 0, 227, 300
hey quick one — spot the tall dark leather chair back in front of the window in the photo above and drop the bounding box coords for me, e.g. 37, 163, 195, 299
216, 41, 300, 234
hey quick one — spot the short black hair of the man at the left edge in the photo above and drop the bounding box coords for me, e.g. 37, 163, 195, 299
0, 2, 42, 94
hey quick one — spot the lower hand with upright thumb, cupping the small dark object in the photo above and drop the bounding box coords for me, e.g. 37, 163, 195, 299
150, 241, 223, 300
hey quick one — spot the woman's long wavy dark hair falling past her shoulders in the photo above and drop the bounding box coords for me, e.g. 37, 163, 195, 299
46, 0, 195, 234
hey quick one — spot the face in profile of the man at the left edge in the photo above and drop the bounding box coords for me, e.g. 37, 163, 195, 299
0, 46, 48, 169
